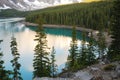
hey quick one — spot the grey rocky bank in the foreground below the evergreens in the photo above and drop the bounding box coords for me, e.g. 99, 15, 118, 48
34, 61, 120, 80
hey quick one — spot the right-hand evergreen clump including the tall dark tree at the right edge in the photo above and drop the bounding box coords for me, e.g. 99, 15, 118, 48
66, 0, 120, 70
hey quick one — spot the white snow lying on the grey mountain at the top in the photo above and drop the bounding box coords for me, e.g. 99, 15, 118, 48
0, 0, 82, 10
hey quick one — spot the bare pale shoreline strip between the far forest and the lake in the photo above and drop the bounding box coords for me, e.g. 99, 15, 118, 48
24, 22, 112, 47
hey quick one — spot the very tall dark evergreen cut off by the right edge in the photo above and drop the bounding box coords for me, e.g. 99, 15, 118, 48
108, 0, 120, 60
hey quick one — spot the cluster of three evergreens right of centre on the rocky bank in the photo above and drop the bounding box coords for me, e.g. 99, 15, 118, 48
66, 30, 97, 71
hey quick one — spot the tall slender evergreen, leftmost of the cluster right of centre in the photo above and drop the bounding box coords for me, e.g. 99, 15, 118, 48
67, 26, 78, 69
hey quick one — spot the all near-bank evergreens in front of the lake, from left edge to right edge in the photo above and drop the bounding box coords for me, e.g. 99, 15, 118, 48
0, 0, 120, 80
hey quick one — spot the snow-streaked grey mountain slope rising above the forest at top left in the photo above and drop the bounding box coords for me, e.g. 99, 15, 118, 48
0, 0, 81, 11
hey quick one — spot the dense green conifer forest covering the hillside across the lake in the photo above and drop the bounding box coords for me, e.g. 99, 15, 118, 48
26, 1, 113, 29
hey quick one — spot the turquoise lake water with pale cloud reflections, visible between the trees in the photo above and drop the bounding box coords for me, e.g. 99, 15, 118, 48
0, 22, 87, 80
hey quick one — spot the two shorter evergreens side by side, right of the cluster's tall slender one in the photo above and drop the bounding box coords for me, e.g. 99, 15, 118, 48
78, 32, 97, 69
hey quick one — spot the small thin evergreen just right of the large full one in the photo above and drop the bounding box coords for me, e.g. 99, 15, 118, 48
51, 47, 57, 77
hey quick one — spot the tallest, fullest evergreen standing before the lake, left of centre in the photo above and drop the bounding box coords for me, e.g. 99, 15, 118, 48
33, 22, 50, 78
